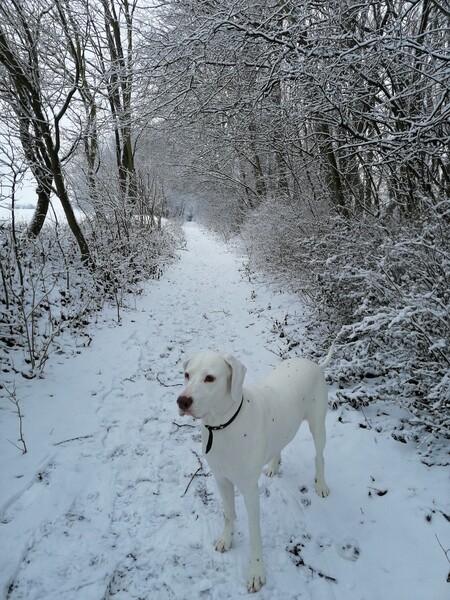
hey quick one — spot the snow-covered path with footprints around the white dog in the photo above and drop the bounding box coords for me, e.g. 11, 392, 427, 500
0, 224, 450, 600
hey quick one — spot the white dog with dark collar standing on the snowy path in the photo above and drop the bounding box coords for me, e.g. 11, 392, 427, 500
177, 348, 333, 592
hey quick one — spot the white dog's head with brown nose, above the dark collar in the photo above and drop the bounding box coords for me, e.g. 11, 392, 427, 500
177, 350, 246, 419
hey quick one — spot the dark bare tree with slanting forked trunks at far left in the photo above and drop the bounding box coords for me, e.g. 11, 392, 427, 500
0, 0, 92, 264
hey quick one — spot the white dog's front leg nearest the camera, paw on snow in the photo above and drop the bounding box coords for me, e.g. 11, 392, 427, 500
241, 482, 266, 592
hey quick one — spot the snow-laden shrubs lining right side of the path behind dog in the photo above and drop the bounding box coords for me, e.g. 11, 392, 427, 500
243, 200, 450, 434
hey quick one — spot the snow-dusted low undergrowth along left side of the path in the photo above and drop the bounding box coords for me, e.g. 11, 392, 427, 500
0, 215, 182, 377
